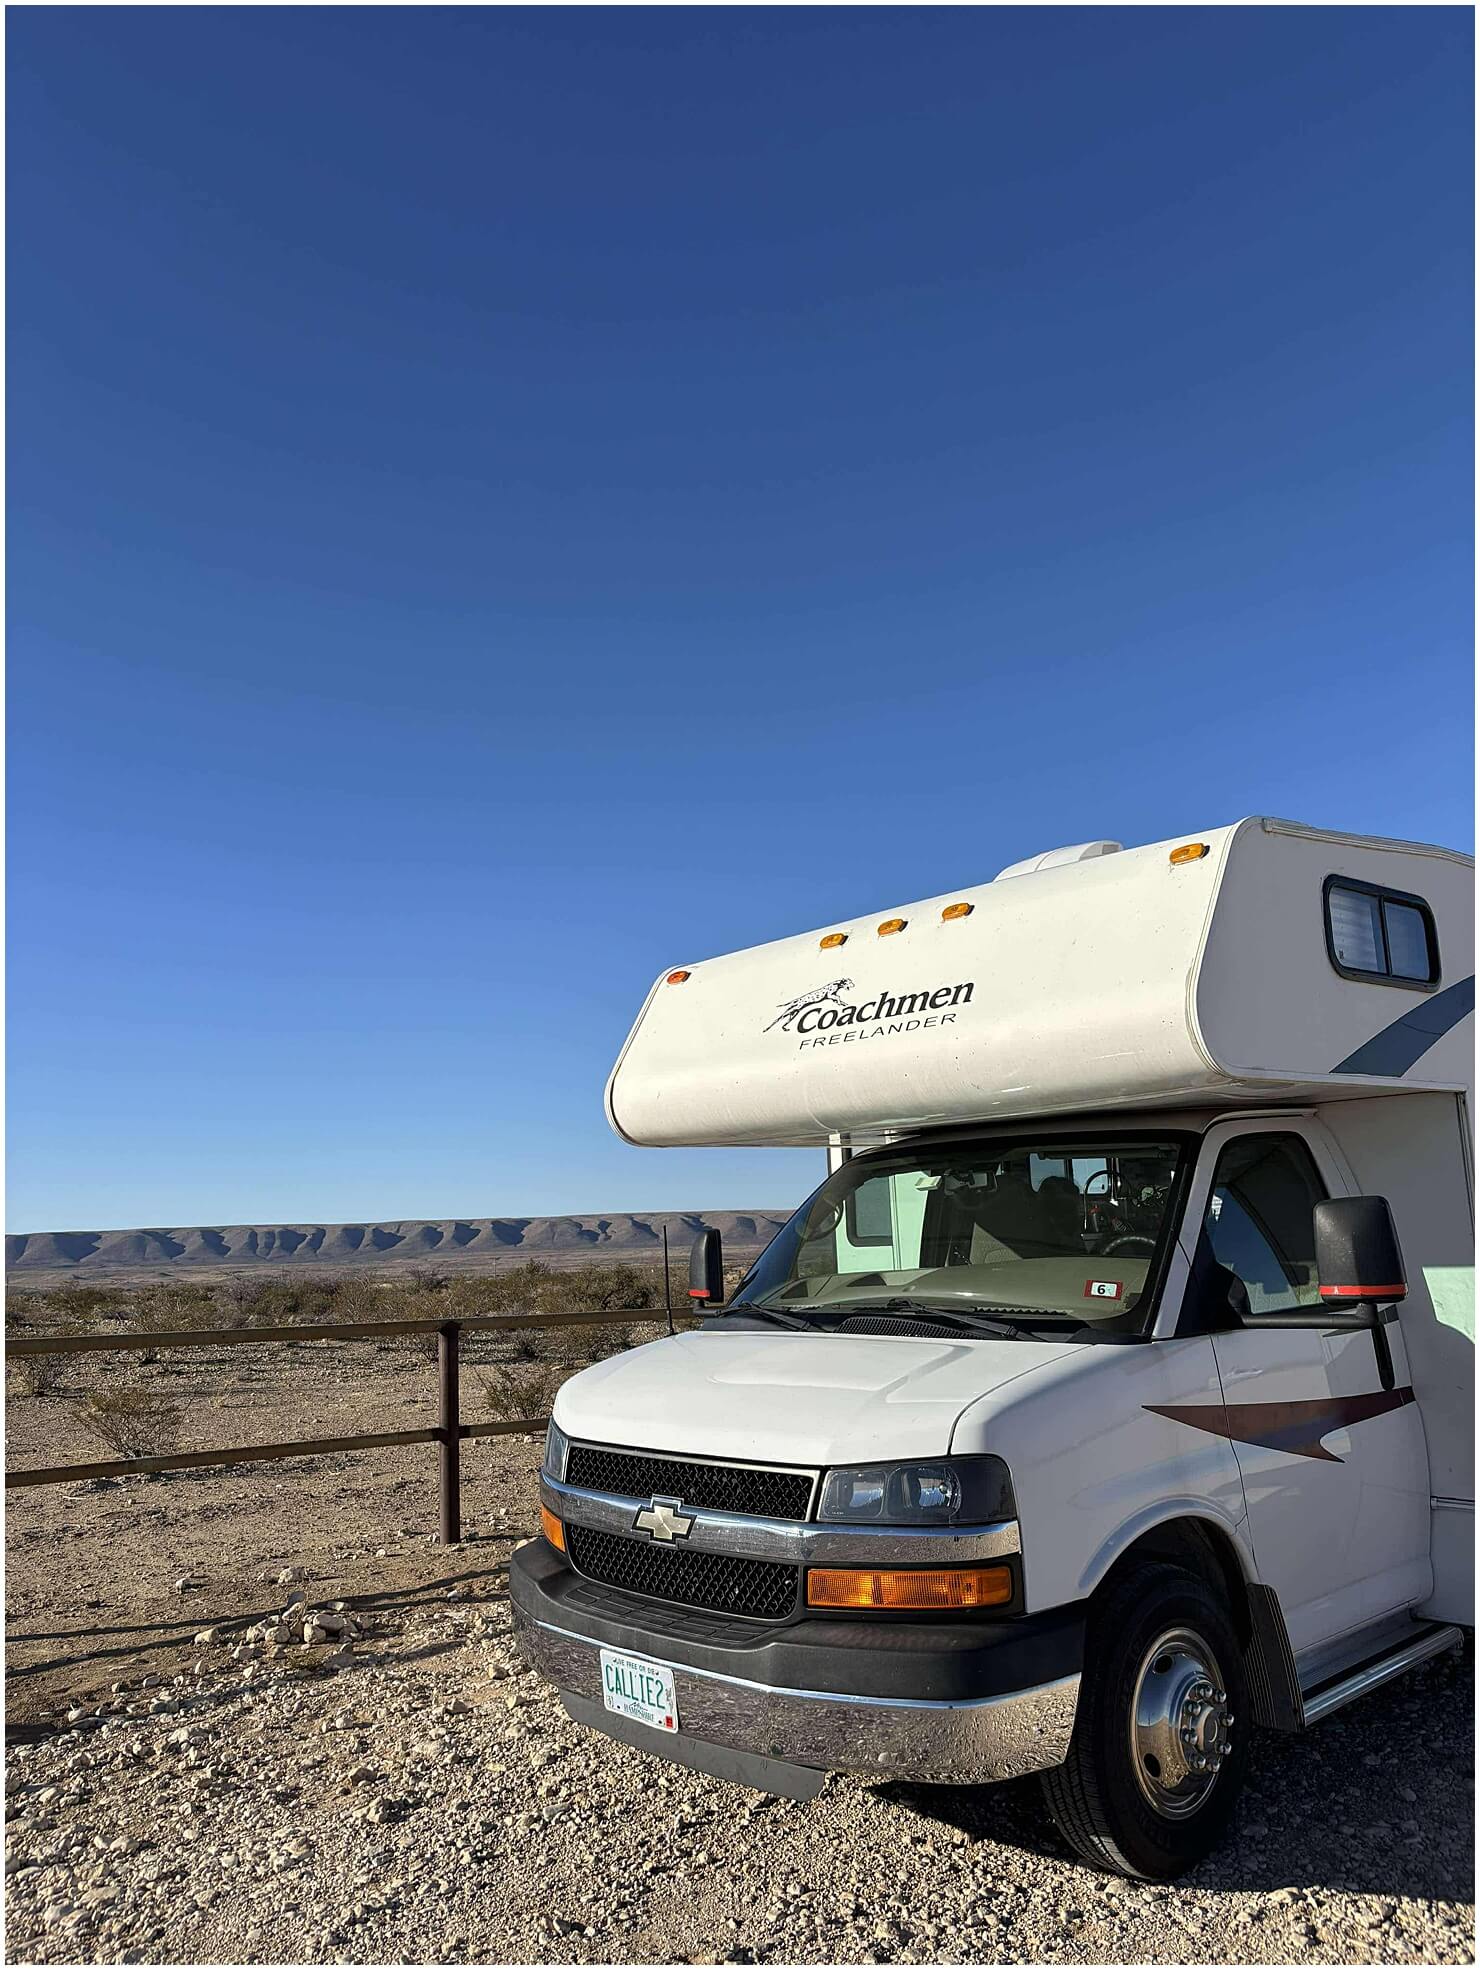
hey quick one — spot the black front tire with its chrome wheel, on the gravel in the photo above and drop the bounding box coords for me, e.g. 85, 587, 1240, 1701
1043, 1562, 1249, 1881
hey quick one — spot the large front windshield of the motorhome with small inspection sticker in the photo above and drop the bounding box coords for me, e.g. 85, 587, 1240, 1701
731, 1135, 1182, 1334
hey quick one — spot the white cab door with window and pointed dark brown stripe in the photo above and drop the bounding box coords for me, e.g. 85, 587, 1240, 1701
1188, 1117, 1433, 1655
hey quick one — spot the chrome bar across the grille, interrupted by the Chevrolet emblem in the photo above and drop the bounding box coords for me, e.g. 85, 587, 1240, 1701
540, 1460, 1023, 1566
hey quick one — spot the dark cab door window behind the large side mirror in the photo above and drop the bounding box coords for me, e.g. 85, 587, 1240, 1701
1204, 1133, 1326, 1318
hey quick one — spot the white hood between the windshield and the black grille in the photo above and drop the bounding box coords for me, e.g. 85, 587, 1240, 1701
554, 1330, 1076, 1466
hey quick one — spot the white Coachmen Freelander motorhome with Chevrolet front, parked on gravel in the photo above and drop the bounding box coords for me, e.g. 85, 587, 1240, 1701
512, 820, 1474, 1877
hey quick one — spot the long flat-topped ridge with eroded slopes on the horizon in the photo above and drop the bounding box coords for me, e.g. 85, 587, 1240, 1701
6, 1212, 788, 1282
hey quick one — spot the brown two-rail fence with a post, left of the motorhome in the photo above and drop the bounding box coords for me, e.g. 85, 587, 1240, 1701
6, 1306, 697, 1546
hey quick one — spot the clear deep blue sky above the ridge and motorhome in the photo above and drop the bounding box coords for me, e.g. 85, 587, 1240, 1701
6, 8, 1472, 1231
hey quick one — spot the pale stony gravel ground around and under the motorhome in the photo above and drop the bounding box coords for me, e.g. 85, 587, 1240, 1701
6, 1359, 1474, 1964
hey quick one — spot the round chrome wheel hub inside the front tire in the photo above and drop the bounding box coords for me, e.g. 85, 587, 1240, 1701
1131, 1627, 1234, 1820
